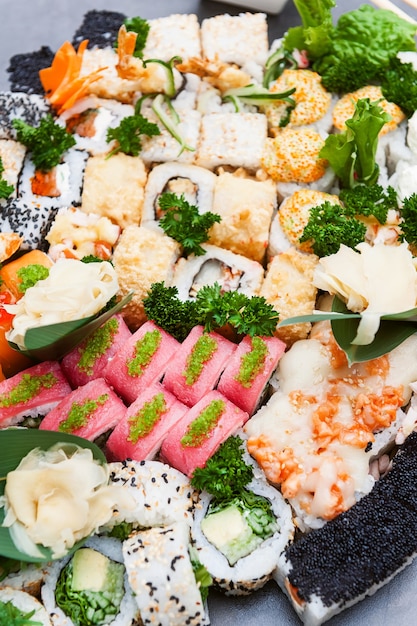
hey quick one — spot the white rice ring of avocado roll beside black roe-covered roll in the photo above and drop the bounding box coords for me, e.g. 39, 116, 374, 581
191, 476, 294, 595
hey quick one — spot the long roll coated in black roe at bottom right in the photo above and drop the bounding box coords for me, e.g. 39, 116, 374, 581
274, 432, 417, 626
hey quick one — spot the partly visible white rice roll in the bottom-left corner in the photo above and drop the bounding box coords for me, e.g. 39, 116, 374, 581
0, 582, 51, 626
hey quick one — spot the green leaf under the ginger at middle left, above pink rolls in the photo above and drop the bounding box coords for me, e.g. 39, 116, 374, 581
9, 292, 133, 361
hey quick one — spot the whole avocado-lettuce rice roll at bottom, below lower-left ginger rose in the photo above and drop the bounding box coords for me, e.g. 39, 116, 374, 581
41, 536, 140, 626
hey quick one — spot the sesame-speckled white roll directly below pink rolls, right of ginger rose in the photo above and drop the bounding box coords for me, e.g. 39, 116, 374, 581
106, 460, 196, 529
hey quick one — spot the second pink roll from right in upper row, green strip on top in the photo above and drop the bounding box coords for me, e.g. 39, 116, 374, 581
164, 326, 237, 406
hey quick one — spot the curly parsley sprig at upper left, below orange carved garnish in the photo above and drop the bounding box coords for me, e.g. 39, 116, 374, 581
12, 113, 75, 172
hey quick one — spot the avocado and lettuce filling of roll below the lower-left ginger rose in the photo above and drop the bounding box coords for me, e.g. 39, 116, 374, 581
55, 548, 125, 626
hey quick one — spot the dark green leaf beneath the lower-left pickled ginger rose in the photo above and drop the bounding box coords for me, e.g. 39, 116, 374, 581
0, 428, 106, 563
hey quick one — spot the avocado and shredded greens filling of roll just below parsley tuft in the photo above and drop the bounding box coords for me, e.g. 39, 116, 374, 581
201, 489, 279, 566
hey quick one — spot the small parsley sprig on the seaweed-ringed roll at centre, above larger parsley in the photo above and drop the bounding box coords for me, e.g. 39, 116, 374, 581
159, 193, 221, 256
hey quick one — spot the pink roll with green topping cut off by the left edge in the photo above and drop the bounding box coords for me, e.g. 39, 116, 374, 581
0, 361, 71, 428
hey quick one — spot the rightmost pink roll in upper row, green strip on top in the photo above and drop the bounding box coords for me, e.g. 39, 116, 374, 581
217, 336, 286, 415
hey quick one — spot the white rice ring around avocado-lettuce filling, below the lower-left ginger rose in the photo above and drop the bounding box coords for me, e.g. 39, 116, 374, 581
41, 536, 139, 626
